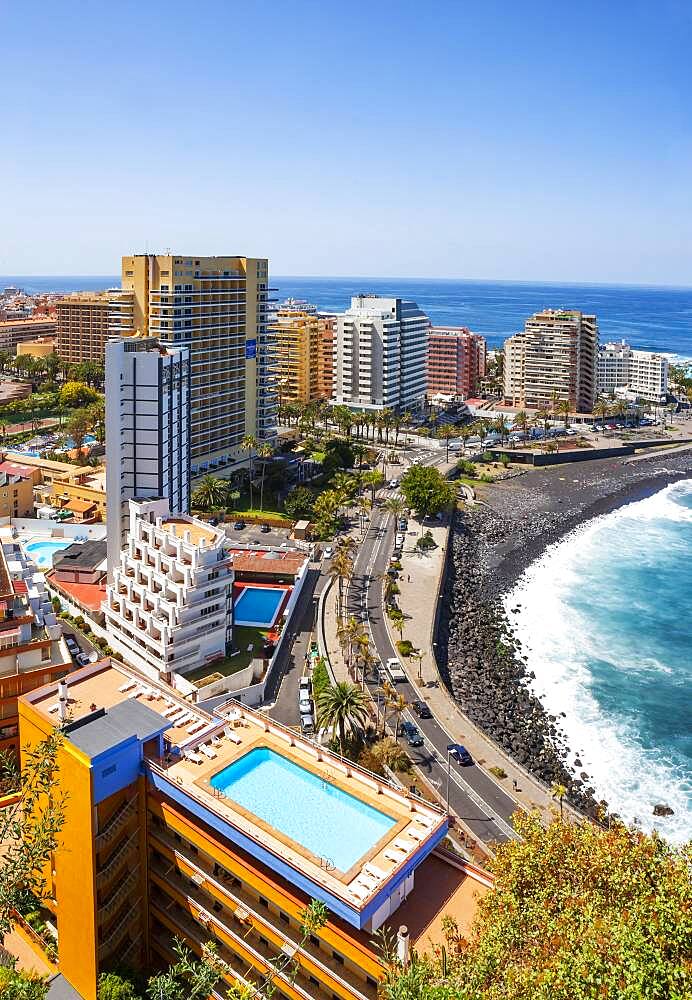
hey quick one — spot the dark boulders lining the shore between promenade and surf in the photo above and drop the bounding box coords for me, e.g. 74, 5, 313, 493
437, 508, 606, 816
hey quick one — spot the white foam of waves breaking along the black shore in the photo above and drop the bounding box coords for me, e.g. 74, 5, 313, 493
505, 481, 692, 841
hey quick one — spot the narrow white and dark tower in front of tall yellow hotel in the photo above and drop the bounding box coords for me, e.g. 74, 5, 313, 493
106, 337, 190, 577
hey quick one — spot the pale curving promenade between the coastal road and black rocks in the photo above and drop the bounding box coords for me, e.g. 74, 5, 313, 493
387, 517, 556, 819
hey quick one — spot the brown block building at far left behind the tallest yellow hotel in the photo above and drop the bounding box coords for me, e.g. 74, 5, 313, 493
56, 291, 117, 364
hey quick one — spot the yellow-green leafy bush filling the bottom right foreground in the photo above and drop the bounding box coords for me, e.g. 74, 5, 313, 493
381, 813, 692, 1000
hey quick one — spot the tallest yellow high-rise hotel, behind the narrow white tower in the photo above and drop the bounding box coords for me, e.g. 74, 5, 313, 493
110, 254, 276, 478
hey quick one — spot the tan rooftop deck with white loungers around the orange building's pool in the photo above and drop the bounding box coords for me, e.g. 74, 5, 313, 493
26, 658, 447, 912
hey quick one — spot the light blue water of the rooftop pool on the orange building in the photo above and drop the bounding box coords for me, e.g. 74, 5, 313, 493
211, 747, 395, 872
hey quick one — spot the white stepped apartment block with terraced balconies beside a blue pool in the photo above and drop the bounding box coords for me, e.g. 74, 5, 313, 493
102, 499, 233, 685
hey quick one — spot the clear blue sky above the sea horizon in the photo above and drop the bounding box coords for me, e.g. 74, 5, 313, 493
0, 0, 692, 285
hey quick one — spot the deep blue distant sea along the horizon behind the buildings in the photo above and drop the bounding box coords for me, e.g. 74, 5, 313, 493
0, 275, 692, 364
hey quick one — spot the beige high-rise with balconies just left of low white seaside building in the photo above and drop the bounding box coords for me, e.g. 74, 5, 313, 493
504, 309, 598, 413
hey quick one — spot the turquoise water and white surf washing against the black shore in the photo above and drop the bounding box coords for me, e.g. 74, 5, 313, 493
505, 479, 692, 842
